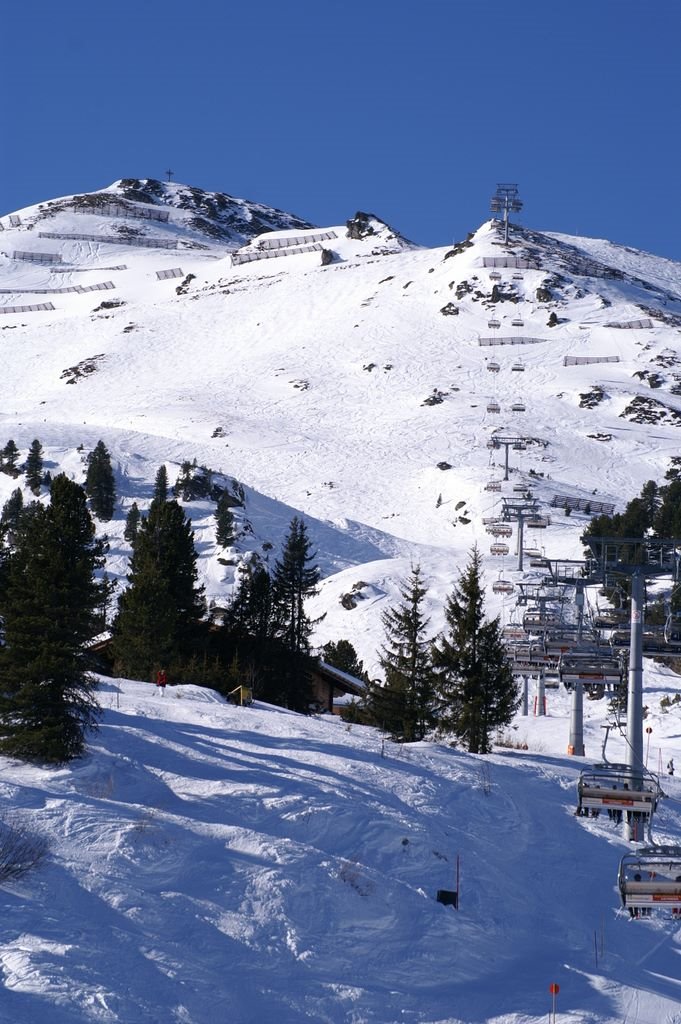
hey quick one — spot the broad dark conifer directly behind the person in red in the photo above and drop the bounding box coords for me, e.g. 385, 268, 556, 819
114, 501, 204, 678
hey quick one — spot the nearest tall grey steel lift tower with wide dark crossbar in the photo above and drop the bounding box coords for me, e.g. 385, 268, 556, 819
585, 537, 681, 838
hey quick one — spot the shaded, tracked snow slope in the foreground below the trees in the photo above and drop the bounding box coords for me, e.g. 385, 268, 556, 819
0, 666, 681, 1024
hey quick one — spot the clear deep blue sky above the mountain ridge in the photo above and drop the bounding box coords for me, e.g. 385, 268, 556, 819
5, 0, 681, 259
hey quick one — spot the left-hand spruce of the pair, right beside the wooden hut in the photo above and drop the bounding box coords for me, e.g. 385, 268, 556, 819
367, 565, 433, 742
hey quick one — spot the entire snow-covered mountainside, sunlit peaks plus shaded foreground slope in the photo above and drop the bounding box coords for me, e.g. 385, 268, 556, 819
0, 179, 681, 1024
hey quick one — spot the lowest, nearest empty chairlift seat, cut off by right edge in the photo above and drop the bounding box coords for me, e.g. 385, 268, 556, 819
618, 846, 681, 918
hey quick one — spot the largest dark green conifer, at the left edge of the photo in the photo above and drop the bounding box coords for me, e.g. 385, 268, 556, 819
0, 474, 101, 764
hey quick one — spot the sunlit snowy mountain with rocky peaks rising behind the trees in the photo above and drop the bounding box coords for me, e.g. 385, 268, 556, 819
0, 179, 681, 670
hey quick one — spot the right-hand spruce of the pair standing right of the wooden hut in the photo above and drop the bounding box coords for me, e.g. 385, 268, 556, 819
432, 548, 520, 754
